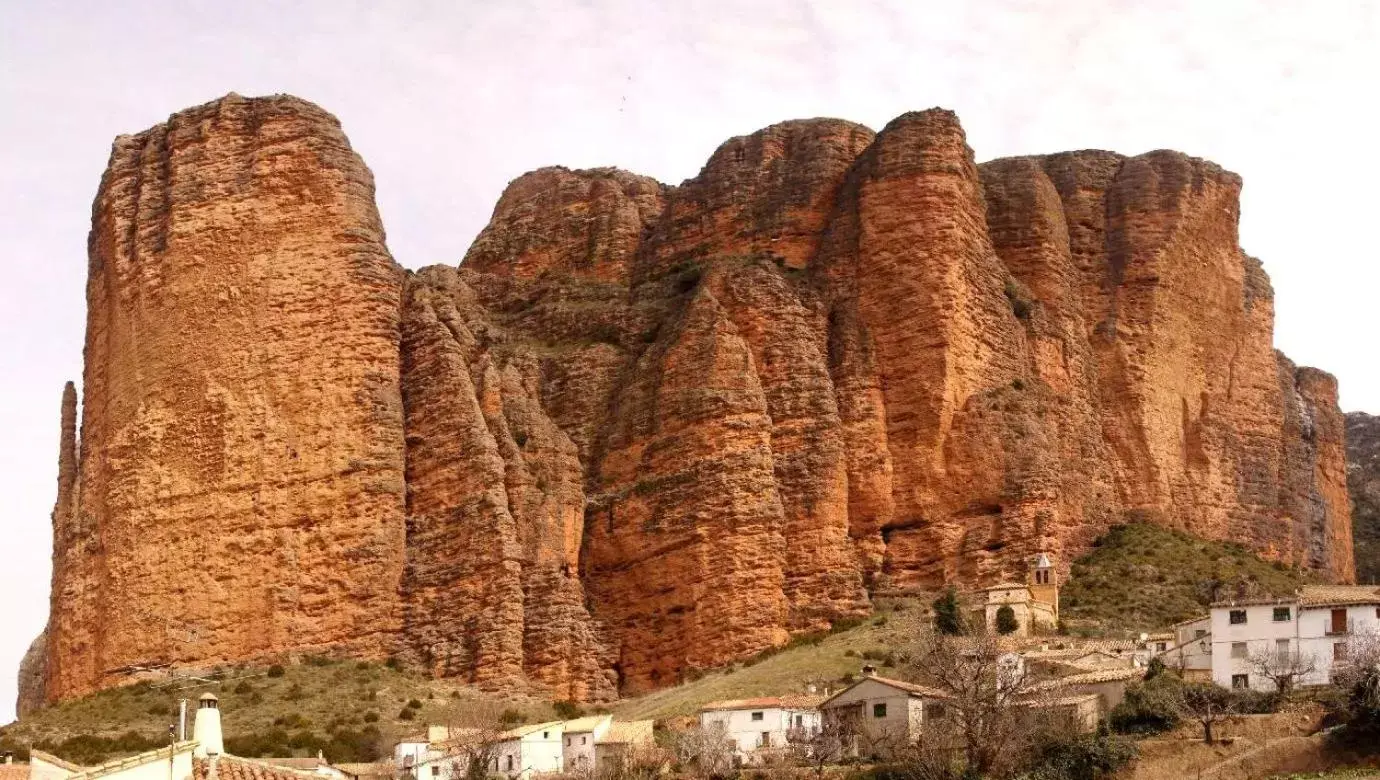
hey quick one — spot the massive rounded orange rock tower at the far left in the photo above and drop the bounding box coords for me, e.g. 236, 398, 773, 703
47, 95, 404, 699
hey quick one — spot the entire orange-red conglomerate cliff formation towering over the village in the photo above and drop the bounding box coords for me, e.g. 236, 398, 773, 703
35, 95, 1354, 700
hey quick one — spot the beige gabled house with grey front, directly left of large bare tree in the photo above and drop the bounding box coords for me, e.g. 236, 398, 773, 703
820, 672, 948, 744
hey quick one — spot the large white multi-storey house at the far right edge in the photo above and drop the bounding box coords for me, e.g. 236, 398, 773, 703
1209, 585, 1380, 690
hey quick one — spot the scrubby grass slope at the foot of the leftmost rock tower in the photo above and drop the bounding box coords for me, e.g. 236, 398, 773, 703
0, 657, 553, 765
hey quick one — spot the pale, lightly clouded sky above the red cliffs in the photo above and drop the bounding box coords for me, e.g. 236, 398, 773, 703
0, 0, 1380, 723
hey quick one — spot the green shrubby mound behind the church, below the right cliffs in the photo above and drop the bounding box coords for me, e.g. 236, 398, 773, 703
1060, 523, 1315, 634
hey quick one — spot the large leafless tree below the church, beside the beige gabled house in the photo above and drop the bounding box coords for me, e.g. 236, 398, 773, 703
907, 632, 1031, 776
